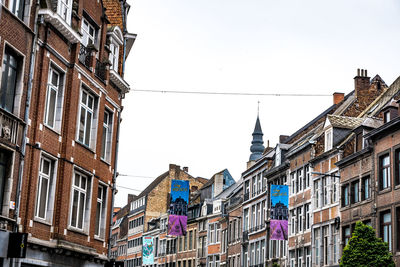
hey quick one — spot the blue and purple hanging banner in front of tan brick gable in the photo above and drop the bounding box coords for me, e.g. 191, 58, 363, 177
168, 180, 189, 236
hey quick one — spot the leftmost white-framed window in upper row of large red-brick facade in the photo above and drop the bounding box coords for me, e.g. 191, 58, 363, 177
44, 66, 64, 130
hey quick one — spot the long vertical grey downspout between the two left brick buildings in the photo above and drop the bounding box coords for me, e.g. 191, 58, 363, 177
14, 0, 39, 232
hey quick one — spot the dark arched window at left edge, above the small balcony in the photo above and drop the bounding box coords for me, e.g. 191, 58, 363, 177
0, 48, 19, 113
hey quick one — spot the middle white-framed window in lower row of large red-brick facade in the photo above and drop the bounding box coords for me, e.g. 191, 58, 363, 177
70, 172, 90, 230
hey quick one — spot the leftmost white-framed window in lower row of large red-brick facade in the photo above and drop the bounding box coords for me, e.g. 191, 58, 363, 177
35, 156, 55, 221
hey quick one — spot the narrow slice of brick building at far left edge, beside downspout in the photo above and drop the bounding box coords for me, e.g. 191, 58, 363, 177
0, 0, 36, 266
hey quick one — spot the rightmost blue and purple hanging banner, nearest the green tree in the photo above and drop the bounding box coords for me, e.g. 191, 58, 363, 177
269, 185, 289, 240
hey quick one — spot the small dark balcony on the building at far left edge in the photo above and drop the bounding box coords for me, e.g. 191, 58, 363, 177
0, 110, 25, 144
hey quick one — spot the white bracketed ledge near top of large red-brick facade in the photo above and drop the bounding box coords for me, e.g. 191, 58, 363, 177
38, 9, 82, 44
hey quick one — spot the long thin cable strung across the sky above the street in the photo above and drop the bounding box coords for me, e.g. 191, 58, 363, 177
132, 89, 332, 97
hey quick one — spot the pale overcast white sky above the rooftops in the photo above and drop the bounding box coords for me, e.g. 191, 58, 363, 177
115, 0, 400, 206
